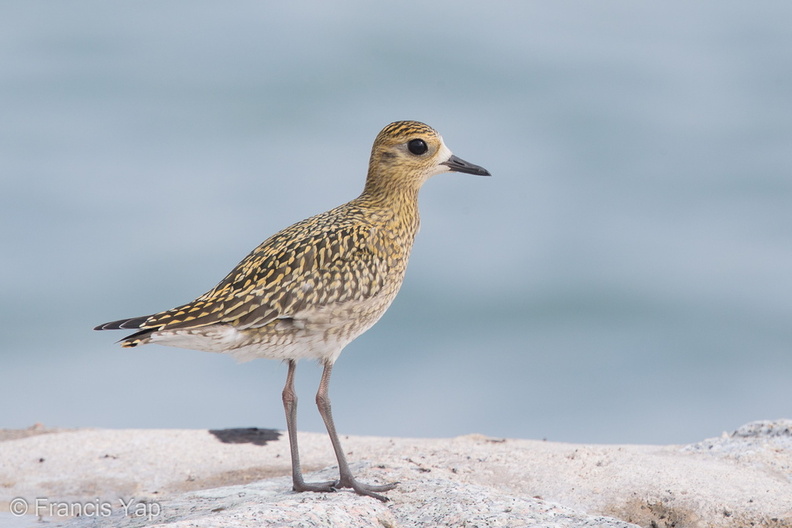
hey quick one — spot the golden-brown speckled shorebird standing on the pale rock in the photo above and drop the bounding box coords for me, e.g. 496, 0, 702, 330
95, 121, 490, 502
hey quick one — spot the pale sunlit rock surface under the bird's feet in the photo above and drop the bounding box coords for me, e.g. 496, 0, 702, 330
0, 420, 792, 528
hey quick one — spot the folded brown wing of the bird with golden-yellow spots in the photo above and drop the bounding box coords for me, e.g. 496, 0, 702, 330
138, 210, 390, 330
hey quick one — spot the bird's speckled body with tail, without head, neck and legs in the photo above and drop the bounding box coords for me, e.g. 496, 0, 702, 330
98, 195, 418, 360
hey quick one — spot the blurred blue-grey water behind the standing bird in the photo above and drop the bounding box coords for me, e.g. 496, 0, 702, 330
0, 0, 792, 443
